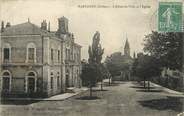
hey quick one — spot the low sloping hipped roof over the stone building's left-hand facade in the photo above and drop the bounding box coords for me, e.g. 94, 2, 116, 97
2, 22, 49, 36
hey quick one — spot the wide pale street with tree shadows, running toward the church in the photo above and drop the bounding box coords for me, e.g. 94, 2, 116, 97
0, 82, 183, 116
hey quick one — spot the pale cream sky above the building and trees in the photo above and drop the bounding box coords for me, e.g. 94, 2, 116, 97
0, 0, 183, 59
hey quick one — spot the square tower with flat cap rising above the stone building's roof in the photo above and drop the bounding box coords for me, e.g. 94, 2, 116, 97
57, 16, 68, 34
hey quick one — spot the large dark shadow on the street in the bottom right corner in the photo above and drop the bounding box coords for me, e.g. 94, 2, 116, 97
138, 97, 184, 112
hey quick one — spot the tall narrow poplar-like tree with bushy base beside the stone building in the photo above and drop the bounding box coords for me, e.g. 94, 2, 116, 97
81, 31, 104, 97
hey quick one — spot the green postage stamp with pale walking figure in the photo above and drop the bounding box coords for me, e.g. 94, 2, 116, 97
158, 2, 182, 32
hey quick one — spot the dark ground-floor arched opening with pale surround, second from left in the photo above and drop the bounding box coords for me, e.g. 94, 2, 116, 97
26, 71, 37, 93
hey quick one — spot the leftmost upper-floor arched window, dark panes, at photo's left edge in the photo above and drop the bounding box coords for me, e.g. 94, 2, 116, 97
3, 43, 11, 62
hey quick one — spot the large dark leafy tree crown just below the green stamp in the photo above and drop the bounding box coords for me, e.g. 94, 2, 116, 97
144, 31, 183, 70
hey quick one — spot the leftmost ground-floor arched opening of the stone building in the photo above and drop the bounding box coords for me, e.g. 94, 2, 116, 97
2, 71, 11, 93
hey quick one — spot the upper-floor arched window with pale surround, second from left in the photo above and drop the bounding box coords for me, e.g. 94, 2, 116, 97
26, 43, 36, 63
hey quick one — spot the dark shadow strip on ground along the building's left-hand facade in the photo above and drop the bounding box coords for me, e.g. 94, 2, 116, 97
0, 100, 39, 105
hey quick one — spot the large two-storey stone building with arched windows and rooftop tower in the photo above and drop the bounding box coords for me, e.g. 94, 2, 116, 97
0, 17, 81, 96
